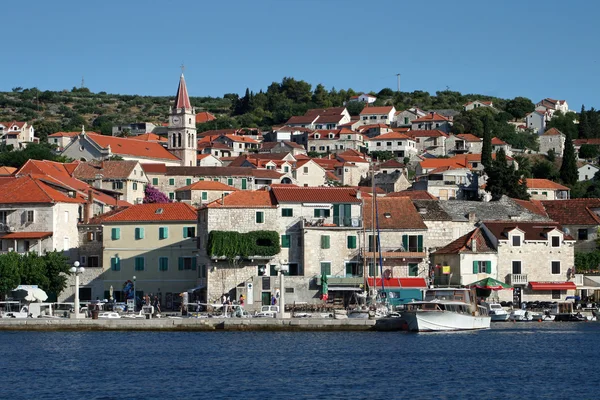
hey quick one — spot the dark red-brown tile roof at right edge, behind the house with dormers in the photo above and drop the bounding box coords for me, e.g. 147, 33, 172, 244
541, 198, 600, 226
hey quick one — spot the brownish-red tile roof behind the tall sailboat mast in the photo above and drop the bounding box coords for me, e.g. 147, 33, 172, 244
363, 197, 427, 230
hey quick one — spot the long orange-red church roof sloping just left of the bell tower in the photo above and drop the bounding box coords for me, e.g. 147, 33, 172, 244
86, 133, 179, 161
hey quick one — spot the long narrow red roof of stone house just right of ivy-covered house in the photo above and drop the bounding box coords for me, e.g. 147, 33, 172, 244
271, 187, 361, 203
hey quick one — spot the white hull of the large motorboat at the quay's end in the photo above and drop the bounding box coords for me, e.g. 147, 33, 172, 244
402, 311, 491, 332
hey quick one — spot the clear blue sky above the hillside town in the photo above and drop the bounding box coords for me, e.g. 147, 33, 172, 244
0, 0, 600, 110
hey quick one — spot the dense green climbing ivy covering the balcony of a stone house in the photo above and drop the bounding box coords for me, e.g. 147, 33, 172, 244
207, 231, 281, 260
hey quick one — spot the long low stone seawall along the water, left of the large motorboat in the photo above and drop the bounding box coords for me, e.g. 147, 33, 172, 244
0, 318, 402, 331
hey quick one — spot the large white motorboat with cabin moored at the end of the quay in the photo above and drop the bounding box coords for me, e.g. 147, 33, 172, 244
401, 288, 491, 332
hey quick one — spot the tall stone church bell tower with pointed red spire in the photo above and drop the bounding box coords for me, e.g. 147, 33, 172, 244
167, 67, 198, 167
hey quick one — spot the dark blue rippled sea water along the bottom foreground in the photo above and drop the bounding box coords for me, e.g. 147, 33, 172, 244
0, 322, 600, 399
